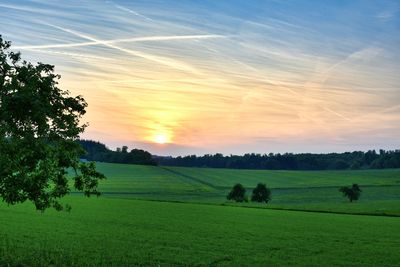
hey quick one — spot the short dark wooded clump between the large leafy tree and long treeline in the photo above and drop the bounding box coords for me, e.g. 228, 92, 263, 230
78, 140, 157, 165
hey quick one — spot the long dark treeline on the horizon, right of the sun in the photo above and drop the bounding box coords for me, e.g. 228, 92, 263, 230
155, 150, 400, 170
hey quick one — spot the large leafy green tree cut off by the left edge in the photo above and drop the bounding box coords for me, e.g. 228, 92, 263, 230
0, 35, 105, 211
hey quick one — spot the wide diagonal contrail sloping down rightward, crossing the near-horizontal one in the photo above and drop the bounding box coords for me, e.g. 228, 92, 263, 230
46, 24, 199, 74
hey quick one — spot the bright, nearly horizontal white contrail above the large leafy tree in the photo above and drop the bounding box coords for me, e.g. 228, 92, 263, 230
13, 34, 226, 49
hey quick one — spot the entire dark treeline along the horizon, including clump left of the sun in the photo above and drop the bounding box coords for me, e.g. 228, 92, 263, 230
78, 140, 400, 170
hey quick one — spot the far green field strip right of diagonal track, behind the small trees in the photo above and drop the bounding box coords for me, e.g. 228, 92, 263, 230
166, 167, 400, 188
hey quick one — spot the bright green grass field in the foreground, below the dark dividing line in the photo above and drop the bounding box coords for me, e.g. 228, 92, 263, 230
0, 196, 400, 266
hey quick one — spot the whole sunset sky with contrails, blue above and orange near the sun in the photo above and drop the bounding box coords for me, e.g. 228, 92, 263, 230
0, 0, 400, 156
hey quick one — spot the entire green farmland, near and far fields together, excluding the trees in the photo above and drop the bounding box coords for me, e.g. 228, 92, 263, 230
0, 163, 400, 266
